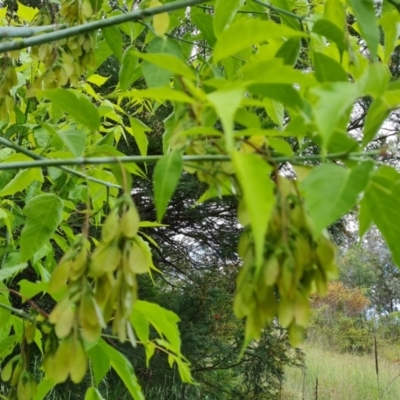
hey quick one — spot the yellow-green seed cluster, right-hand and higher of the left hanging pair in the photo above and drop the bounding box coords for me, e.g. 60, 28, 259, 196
89, 195, 153, 342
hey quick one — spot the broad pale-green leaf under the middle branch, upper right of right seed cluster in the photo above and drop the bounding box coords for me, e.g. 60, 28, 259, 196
301, 162, 373, 234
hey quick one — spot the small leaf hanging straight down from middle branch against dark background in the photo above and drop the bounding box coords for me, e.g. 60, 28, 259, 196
153, 151, 182, 222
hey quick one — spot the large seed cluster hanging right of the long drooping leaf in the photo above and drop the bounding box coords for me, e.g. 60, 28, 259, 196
234, 177, 337, 345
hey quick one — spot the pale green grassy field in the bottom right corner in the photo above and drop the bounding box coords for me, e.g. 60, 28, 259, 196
282, 344, 400, 400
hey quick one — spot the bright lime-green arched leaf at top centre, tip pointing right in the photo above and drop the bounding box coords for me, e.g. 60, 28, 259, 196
213, 18, 307, 62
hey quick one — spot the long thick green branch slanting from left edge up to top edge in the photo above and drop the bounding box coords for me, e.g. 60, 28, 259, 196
0, 0, 208, 53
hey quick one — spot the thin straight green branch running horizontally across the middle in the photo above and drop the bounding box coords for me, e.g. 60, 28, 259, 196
0, 150, 384, 170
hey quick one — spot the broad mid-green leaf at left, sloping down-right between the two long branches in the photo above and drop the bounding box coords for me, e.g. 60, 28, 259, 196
41, 89, 100, 131
